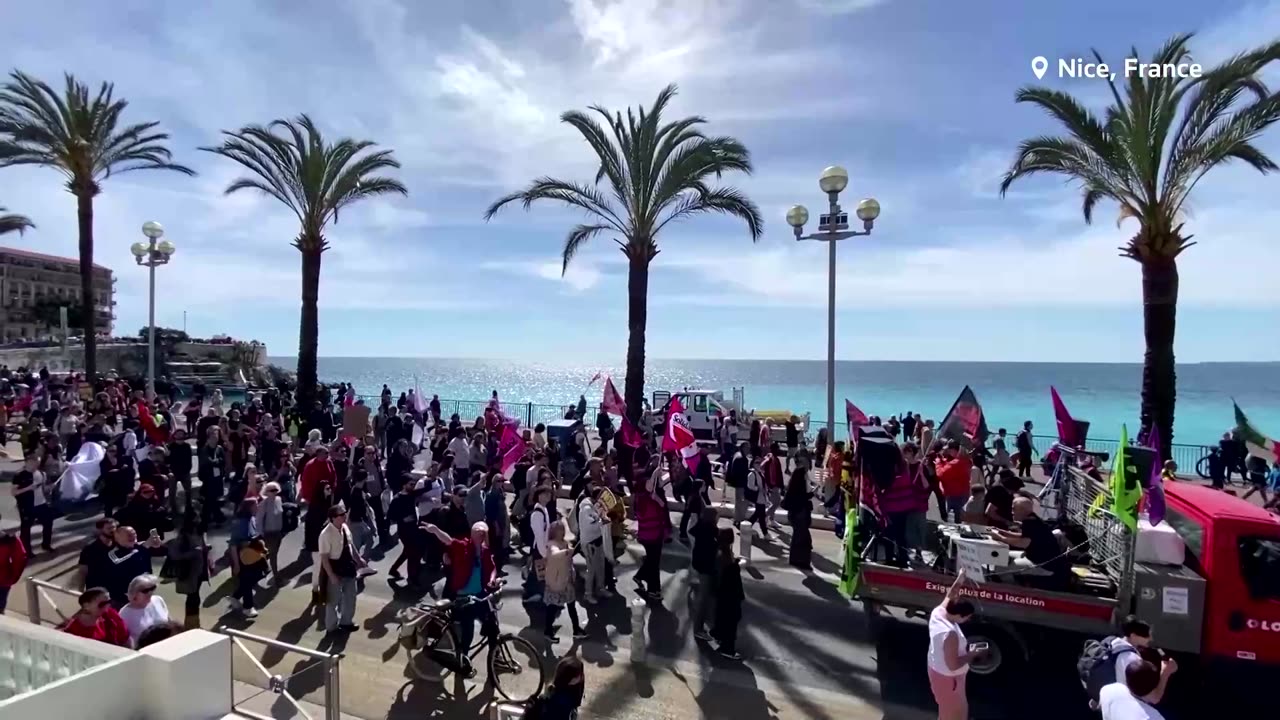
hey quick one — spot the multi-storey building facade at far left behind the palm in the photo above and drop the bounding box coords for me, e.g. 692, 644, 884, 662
0, 247, 115, 342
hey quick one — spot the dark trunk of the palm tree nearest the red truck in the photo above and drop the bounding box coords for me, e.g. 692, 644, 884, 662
1140, 258, 1178, 460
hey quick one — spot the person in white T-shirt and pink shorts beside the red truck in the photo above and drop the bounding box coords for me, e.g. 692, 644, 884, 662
928, 570, 988, 720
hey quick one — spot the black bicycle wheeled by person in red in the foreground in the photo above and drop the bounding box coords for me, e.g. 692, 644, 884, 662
399, 591, 547, 703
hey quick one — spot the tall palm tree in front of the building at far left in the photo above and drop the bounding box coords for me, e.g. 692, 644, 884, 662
0, 70, 196, 378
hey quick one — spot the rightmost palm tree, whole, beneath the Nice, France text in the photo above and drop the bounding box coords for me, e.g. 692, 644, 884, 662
1000, 35, 1280, 459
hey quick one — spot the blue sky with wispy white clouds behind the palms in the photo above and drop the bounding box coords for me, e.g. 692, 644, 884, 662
0, 0, 1280, 361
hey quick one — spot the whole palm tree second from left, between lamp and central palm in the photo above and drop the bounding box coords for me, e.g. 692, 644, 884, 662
201, 115, 408, 409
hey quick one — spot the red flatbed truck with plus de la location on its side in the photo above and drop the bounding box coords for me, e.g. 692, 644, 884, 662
858, 448, 1280, 697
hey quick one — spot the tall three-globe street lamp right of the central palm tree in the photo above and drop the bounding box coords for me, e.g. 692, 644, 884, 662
787, 165, 879, 442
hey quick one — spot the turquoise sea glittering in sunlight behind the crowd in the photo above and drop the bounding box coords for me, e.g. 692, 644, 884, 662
271, 357, 1280, 445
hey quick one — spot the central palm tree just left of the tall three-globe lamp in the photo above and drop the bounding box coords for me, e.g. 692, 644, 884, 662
484, 85, 764, 421
